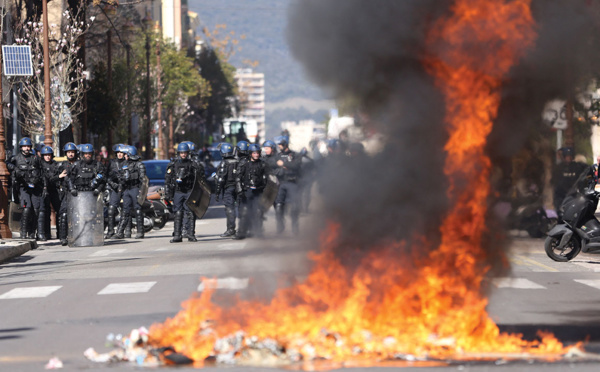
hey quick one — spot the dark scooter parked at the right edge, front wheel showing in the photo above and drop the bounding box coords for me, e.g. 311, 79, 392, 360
544, 167, 600, 262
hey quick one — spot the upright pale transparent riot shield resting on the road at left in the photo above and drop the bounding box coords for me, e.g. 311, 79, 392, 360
67, 191, 104, 247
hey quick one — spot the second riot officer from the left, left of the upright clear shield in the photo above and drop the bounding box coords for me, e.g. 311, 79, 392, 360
38, 146, 62, 239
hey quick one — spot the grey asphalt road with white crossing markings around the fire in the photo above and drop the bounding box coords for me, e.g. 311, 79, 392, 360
0, 206, 600, 371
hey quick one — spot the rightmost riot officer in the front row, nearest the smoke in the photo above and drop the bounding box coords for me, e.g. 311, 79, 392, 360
274, 136, 302, 234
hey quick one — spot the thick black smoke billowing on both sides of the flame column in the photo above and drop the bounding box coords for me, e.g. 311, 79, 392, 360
287, 0, 600, 256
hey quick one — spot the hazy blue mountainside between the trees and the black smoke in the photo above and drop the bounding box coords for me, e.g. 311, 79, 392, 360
188, 0, 331, 129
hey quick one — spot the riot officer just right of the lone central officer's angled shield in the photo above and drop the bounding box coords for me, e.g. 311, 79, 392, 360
215, 142, 242, 238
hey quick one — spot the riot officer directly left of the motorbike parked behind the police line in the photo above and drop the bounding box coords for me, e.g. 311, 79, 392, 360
114, 146, 146, 239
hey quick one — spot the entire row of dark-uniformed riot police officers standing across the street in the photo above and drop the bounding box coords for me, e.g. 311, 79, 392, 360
7, 136, 310, 245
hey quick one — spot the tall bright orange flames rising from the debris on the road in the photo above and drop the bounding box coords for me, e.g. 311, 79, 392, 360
150, 0, 565, 361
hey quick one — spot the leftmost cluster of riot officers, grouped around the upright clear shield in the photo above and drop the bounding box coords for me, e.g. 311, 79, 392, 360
7, 137, 145, 245
